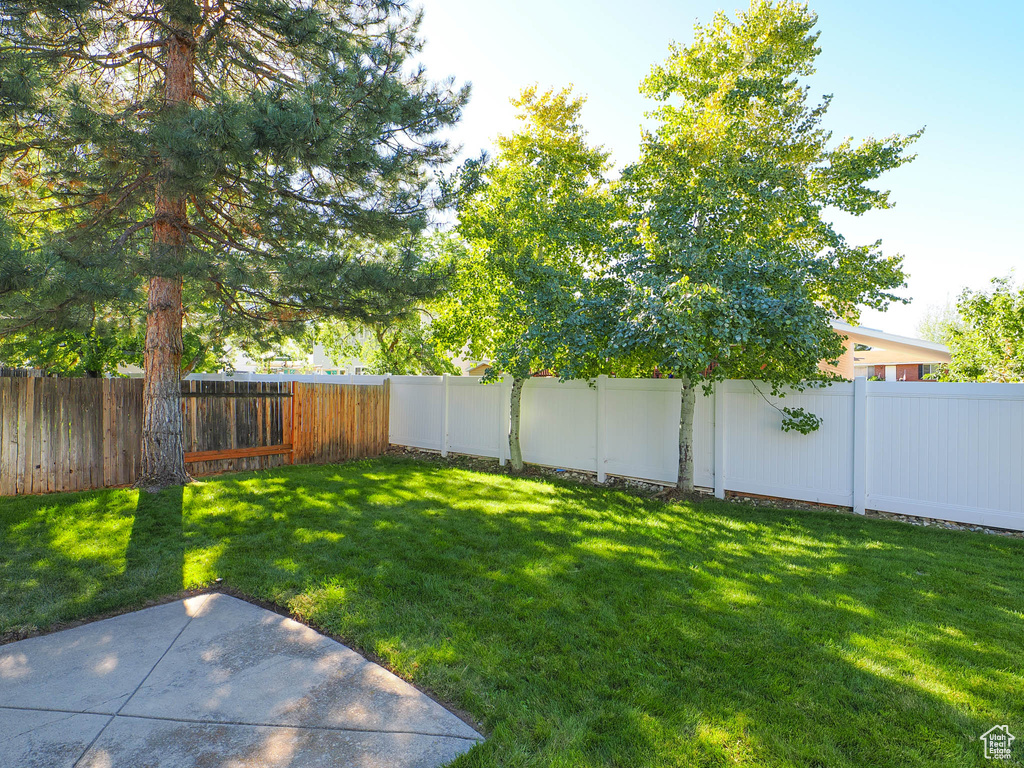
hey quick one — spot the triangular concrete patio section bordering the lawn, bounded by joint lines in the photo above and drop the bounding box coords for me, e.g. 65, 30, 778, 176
122, 595, 477, 738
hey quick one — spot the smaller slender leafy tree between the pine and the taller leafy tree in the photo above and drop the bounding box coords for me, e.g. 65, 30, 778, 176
434, 87, 613, 469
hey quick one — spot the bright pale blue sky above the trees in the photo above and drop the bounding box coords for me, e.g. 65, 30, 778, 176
421, 0, 1024, 335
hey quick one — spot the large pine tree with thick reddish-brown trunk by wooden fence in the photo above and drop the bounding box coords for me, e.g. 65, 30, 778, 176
0, 0, 468, 487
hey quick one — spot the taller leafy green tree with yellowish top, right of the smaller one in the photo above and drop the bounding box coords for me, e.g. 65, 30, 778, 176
615, 0, 921, 489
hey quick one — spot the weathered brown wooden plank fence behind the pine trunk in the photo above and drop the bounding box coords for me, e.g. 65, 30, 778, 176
0, 377, 389, 496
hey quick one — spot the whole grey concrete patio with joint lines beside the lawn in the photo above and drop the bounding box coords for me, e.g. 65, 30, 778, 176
0, 594, 482, 768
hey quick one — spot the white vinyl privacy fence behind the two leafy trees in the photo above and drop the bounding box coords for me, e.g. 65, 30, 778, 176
385, 376, 1024, 529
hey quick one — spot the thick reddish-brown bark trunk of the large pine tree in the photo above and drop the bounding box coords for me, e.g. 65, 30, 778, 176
137, 19, 196, 490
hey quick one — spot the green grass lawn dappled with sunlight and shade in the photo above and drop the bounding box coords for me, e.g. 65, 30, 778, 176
0, 460, 1024, 768
